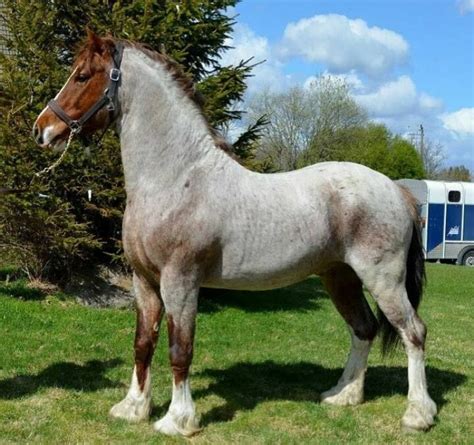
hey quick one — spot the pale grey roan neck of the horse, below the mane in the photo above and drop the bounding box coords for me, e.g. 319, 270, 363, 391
119, 49, 234, 195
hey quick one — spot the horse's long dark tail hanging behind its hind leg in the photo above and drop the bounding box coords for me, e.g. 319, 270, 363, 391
378, 216, 426, 355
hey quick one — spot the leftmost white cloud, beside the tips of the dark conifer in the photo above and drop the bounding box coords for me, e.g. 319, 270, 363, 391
221, 24, 290, 94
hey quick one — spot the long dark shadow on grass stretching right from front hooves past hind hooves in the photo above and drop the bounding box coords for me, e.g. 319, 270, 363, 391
186, 361, 467, 425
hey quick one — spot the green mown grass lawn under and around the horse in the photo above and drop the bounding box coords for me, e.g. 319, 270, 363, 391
0, 264, 474, 444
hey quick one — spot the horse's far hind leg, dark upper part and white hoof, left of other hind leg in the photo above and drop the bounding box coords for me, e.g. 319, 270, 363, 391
321, 264, 377, 405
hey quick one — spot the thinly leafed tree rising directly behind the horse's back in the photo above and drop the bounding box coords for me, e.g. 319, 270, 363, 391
249, 76, 367, 170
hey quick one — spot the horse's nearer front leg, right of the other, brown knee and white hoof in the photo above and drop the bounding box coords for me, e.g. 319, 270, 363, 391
154, 271, 200, 436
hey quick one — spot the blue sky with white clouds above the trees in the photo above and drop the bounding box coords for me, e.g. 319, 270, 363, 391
223, 0, 474, 172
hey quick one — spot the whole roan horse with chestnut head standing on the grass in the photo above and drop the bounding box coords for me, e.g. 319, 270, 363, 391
33, 32, 437, 436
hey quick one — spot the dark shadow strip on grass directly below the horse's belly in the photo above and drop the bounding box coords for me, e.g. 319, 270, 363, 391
199, 277, 328, 313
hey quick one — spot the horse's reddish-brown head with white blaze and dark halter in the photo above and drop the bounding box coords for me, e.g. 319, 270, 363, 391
33, 31, 121, 148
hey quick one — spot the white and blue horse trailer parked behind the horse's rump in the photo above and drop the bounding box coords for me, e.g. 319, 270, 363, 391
397, 179, 474, 267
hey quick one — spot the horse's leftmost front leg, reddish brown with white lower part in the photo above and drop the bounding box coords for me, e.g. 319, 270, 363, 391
110, 274, 163, 422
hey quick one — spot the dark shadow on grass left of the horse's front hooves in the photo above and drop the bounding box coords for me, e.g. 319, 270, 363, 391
0, 359, 123, 400
